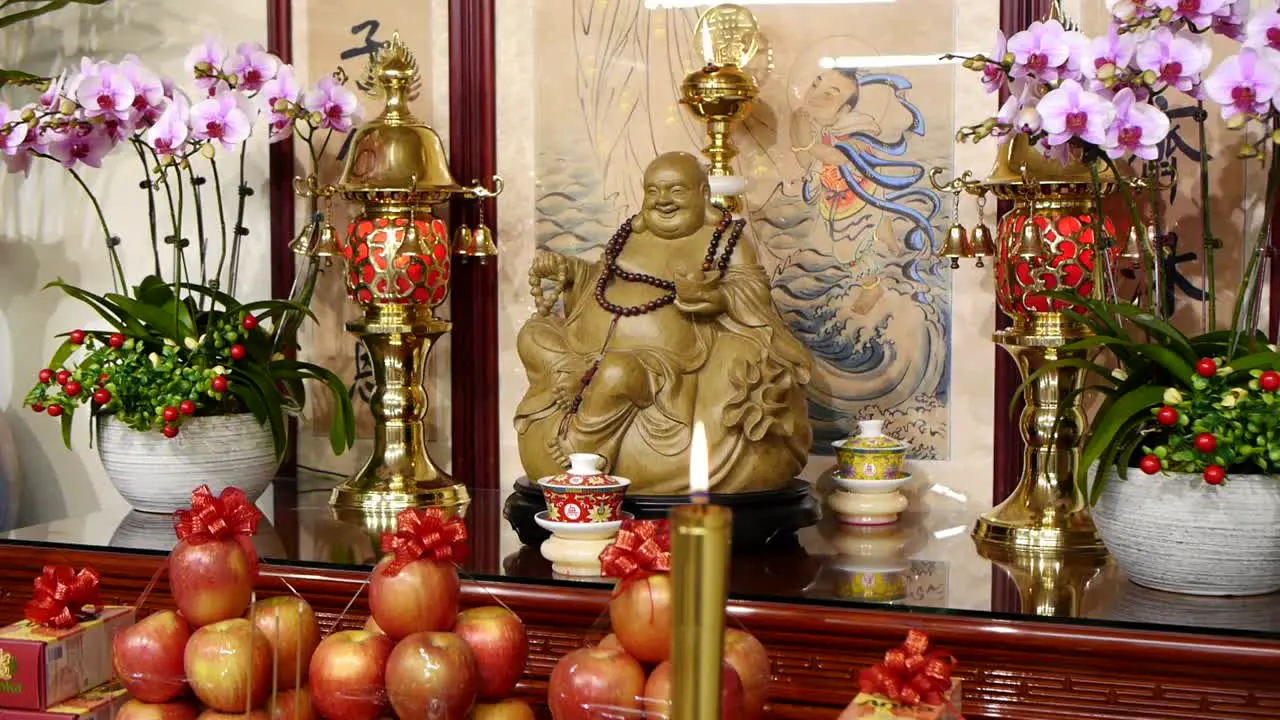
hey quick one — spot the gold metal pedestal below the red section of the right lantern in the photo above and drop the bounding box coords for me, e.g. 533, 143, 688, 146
973, 313, 1106, 555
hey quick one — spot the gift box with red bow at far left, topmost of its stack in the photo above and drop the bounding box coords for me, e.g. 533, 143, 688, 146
0, 565, 134, 710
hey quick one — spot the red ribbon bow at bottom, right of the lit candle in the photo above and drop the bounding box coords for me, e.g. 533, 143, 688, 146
858, 630, 955, 706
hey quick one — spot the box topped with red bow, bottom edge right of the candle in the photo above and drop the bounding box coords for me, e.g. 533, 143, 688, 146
840, 630, 964, 720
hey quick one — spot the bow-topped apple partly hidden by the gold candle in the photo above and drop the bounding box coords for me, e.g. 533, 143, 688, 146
600, 520, 672, 664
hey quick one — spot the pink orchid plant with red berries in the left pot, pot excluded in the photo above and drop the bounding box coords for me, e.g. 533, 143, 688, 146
0, 38, 358, 452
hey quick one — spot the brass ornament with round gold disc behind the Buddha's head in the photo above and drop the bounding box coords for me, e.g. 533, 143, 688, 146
680, 5, 760, 213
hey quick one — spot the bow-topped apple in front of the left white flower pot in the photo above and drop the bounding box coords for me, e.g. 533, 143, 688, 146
169, 486, 262, 628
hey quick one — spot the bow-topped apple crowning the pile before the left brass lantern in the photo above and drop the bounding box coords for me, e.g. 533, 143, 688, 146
369, 507, 467, 641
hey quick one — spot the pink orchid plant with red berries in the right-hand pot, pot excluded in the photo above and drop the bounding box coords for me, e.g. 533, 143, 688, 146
960, 0, 1280, 491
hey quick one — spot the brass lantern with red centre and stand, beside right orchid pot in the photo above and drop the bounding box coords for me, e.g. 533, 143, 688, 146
929, 135, 1116, 555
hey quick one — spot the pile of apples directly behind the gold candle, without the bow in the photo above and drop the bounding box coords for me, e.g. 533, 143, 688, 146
547, 573, 771, 720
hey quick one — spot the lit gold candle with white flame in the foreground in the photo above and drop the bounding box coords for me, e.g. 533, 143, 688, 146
671, 423, 733, 720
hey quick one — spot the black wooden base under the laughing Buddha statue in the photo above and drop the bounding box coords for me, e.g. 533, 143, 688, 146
502, 478, 818, 551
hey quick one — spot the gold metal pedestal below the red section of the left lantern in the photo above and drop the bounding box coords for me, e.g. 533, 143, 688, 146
329, 304, 470, 529
